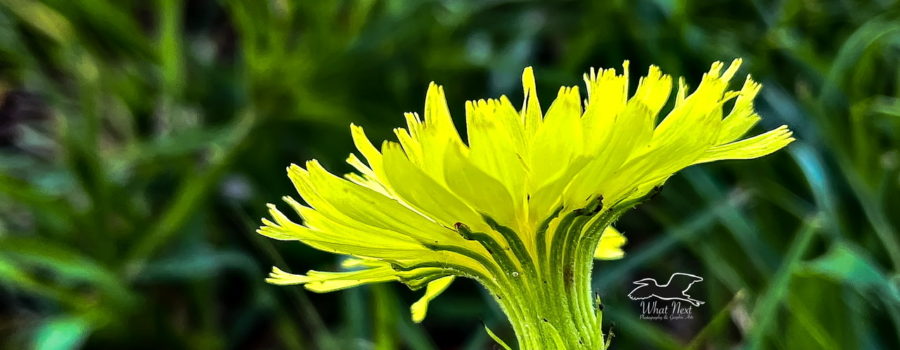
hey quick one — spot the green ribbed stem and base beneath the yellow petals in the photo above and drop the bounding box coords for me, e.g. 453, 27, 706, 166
491, 211, 614, 350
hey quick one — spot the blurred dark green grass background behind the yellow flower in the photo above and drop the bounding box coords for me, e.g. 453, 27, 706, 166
0, 0, 900, 350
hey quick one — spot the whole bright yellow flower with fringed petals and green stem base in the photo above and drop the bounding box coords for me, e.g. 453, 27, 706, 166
258, 60, 793, 349
